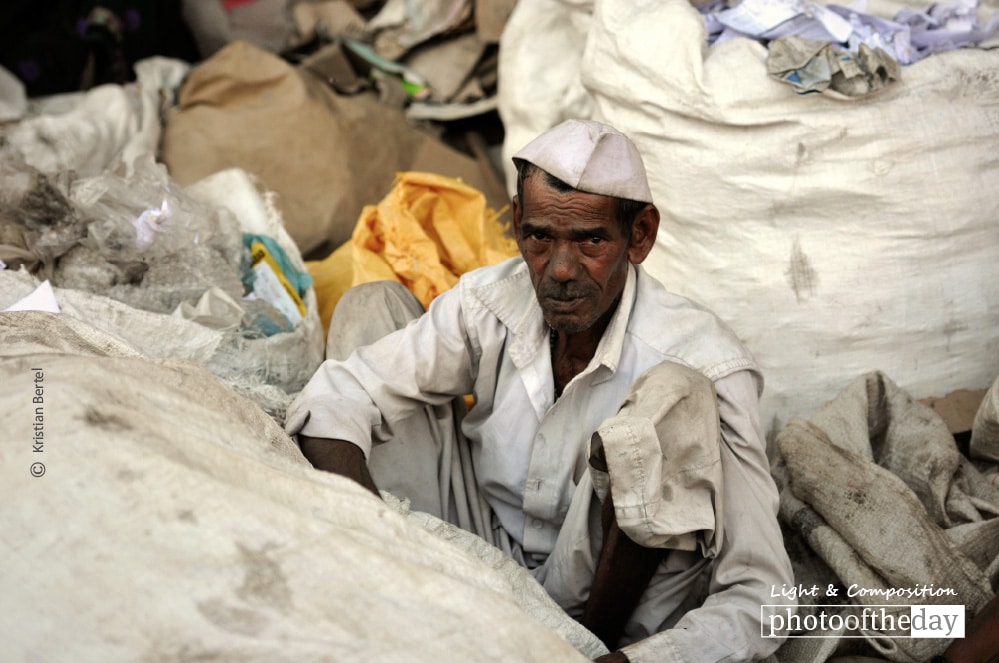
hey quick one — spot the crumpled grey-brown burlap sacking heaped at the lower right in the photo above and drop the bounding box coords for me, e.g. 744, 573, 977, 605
772, 373, 999, 663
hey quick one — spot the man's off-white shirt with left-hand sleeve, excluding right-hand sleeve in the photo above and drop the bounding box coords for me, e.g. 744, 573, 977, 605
286, 258, 762, 555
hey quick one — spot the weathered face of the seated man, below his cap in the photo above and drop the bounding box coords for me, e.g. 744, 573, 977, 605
514, 173, 632, 334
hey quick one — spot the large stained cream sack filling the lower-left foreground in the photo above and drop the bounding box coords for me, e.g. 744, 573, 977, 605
0, 312, 599, 663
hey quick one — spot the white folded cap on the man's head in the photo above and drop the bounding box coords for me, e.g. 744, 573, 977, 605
513, 120, 652, 203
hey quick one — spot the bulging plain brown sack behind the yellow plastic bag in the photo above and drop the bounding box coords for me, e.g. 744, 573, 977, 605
162, 42, 425, 254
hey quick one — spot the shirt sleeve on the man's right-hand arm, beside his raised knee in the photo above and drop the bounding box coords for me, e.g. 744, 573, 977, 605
623, 371, 793, 663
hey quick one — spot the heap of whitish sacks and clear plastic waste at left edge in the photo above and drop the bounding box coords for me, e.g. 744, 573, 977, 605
0, 60, 324, 420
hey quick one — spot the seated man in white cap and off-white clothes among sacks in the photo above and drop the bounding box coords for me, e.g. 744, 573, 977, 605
287, 120, 792, 662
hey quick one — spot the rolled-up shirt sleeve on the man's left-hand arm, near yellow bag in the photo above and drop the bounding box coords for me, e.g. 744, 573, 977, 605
285, 285, 475, 457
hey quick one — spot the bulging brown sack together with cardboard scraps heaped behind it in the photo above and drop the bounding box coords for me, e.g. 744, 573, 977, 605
163, 0, 513, 258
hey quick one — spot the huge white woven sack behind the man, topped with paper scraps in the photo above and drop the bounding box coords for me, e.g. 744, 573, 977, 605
500, 0, 999, 431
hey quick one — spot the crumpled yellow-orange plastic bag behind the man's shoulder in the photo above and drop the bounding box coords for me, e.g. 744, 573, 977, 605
307, 172, 518, 332
